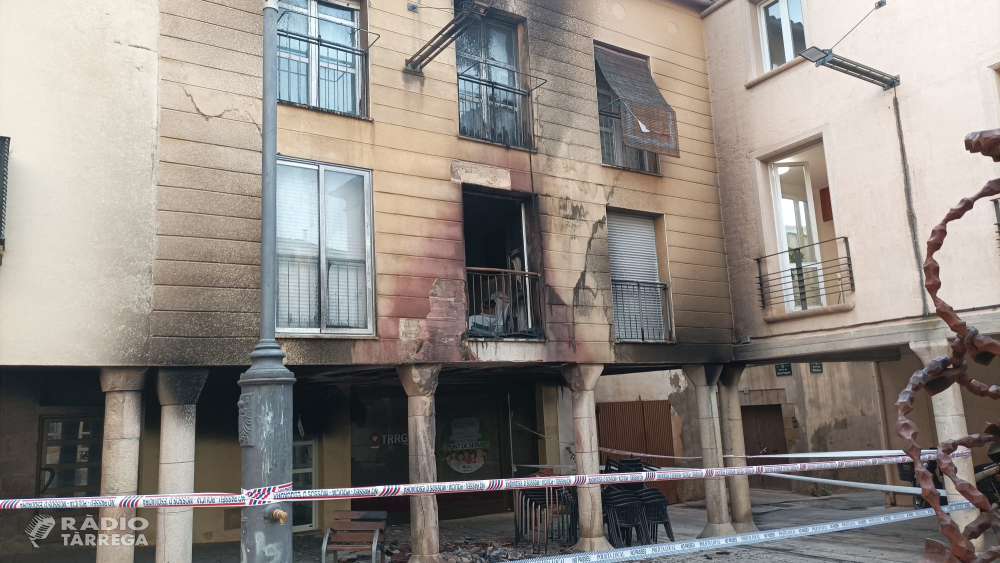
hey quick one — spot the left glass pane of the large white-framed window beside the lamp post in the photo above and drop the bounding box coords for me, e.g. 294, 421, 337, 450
277, 164, 320, 328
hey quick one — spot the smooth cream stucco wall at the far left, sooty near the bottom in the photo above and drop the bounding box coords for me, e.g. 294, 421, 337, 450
0, 0, 158, 365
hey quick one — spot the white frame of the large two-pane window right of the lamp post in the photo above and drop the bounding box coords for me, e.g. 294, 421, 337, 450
274, 157, 375, 337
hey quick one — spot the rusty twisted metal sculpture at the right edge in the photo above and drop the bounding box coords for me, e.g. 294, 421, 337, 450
896, 129, 1000, 563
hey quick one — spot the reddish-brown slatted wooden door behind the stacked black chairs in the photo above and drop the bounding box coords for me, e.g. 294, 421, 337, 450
597, 401, 677, 502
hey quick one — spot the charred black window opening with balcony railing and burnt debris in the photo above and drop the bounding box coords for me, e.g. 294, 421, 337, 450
463, 191, 542, 338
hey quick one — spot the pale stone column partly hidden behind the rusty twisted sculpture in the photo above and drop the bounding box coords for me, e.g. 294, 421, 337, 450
910, 338, 986, 553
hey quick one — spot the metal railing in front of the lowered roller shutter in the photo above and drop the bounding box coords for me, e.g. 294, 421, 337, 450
611, 280, 671, 342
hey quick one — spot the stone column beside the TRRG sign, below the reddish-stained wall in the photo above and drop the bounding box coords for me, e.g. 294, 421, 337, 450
396, 364, 444, 563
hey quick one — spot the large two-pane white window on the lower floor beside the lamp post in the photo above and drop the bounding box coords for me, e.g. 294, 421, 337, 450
277, 161, 375, 335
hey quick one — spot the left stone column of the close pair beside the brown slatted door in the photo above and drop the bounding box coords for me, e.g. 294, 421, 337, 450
682, 364, 736, 538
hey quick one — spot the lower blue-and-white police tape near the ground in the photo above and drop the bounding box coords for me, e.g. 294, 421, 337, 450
531, 502, 975, 563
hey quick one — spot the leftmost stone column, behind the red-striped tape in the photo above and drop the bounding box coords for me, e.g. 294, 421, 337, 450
97, 368, 146, 563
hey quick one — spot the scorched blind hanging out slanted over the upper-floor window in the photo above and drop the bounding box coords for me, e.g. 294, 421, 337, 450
594, 47, 680, 157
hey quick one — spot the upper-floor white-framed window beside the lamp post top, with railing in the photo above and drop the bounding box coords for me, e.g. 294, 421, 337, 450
278, 0, 367, 117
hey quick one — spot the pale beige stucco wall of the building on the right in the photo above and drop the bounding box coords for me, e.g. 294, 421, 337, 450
704, 0, 1000, 340
